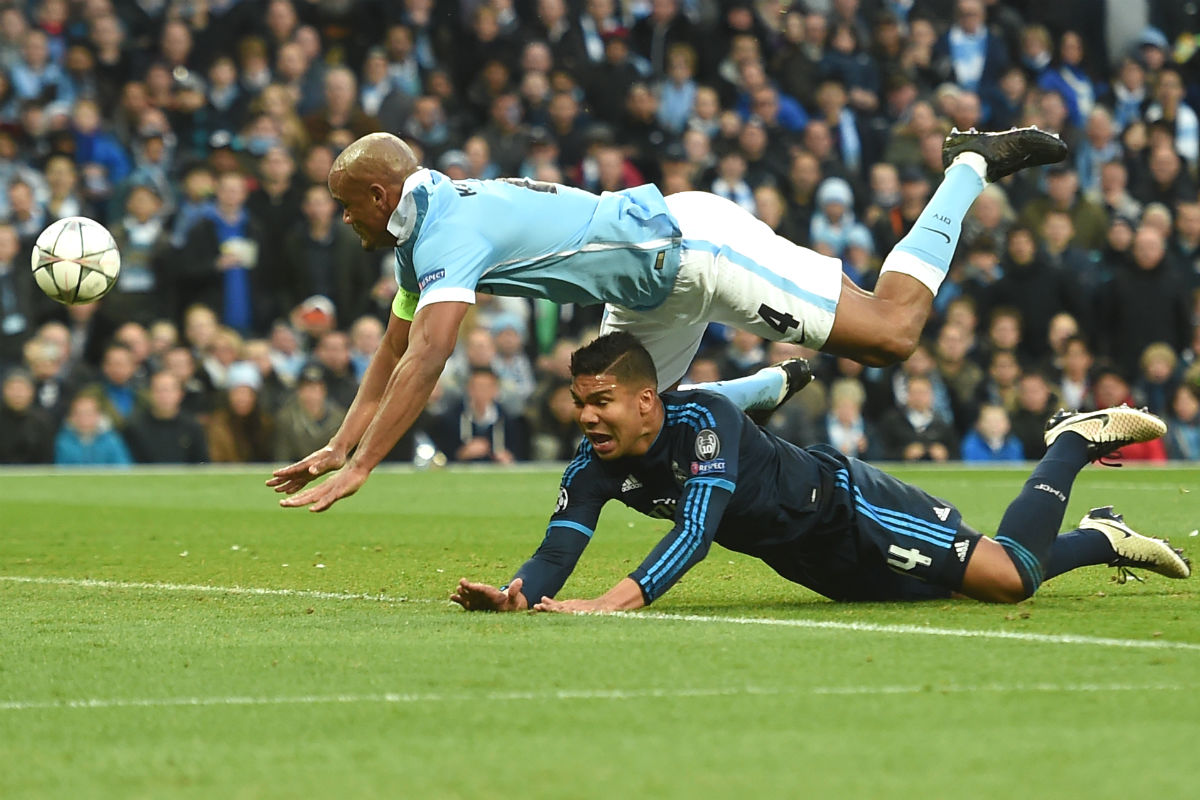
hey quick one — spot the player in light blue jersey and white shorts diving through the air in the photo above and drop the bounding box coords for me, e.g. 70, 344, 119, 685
268, 128, 1067, 511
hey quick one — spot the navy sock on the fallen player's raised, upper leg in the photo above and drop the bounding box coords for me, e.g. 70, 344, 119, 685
996, 432, 1087, 597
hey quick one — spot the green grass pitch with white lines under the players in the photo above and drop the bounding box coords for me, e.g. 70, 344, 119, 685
0, 468, 1200, 800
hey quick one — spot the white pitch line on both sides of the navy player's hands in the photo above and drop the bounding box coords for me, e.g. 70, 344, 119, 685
0, 575, 1200, 651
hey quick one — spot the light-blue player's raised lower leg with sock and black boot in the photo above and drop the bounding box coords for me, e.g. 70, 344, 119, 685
821, 128, 1067, 366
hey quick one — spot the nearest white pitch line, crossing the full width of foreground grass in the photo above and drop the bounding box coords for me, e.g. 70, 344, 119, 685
0, 684, 1195, 711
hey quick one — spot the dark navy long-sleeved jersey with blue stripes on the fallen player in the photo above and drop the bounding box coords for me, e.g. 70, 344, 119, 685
515, 390, 854, 606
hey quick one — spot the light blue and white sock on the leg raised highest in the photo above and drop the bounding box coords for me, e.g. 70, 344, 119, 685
880, 154, 986, 296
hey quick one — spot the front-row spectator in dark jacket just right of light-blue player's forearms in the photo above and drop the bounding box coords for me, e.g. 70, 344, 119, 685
432, 367, 528, 464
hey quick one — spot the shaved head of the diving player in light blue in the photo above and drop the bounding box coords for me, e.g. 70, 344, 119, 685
329, 133, 420, 249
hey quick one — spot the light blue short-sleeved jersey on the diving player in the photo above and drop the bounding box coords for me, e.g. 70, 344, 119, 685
388, 169, 682, 319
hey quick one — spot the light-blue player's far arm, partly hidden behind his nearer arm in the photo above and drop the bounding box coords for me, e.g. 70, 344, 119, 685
266, 314, 412, 494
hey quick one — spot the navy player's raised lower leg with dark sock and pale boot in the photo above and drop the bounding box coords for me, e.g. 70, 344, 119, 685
961, 407, 1166, 602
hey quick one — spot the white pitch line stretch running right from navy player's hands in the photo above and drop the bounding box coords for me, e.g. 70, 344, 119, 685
605, 612, 1200, 650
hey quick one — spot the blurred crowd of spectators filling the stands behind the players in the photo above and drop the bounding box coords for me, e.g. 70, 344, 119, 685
0, 0, 1200, 464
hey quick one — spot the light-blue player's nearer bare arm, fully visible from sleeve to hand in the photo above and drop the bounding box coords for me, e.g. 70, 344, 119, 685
280, 302, 469, 511
